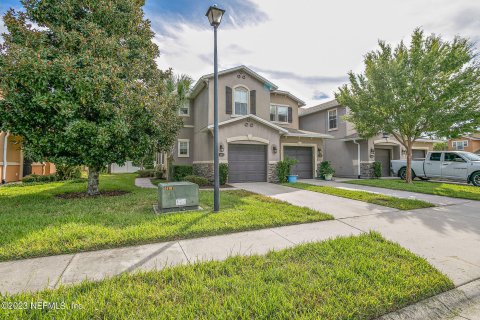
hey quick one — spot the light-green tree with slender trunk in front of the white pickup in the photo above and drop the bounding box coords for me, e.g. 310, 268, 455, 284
335, 29, 480, 182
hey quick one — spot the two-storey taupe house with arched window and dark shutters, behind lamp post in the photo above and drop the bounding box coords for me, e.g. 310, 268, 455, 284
169, 66, 332, 182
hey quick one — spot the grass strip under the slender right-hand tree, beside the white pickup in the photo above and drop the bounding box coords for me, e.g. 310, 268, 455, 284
345, 179, 480, 201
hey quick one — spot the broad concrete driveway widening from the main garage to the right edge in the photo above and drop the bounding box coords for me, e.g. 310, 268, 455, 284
234, 183, 480, 286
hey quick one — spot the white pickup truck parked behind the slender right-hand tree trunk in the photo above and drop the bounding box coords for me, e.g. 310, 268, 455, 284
390, 151, 480, 187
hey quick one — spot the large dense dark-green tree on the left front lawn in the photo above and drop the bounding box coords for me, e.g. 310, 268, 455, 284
0, 0, 182, 195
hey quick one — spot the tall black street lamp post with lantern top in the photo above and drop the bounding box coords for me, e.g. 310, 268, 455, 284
205, 5, 225, 212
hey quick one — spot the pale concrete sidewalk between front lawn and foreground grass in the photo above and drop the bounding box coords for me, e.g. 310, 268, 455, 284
0, 221, 361, 293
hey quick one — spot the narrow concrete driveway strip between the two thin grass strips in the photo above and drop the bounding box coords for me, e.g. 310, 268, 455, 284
299, 179, 471, 206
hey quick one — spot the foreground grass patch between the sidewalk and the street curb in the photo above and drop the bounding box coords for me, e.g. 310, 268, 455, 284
0, 233, 453, 319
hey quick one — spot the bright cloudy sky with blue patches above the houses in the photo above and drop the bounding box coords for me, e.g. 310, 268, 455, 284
0, 0, 480, 106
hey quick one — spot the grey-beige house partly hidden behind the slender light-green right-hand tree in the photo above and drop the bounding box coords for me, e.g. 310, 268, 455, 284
299, 100, 441, 177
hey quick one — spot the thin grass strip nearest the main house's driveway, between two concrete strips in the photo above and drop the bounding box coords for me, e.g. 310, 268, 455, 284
285, 182, 434, 210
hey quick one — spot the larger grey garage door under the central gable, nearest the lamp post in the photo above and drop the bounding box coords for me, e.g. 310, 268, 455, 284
228, 144, 267, 182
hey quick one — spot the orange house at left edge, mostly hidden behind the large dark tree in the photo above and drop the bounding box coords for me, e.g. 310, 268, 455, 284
0, 131, 55, 183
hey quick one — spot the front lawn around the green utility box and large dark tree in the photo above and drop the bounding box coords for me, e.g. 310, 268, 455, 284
0, 174, 332, 261
